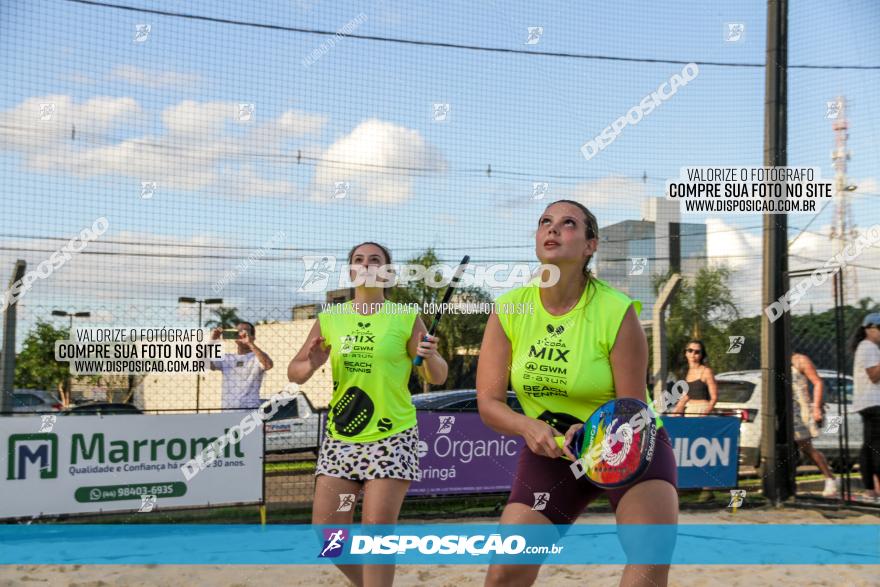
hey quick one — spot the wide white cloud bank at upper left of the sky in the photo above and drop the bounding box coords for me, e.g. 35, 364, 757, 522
0, 95, 326, 198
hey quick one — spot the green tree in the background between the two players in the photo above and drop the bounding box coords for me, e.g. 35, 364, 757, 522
386, 248, 492, 391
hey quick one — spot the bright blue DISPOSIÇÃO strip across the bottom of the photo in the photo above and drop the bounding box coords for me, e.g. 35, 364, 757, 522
0, 523, 880, 565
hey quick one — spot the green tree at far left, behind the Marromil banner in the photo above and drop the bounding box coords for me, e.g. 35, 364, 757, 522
15, 320, 70, 393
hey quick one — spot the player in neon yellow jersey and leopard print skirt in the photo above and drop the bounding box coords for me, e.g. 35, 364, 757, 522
287, 242, 447, 585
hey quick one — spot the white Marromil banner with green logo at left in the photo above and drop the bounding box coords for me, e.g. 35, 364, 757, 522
0, 413, 263, 518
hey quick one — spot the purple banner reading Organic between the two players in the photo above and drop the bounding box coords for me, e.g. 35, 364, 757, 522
409, 412, 525, 495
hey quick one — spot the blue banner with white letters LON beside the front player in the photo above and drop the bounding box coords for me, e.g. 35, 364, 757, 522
663, 416, 740, 489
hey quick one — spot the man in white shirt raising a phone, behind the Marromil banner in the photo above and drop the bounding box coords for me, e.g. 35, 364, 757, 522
209, 322, 273, 410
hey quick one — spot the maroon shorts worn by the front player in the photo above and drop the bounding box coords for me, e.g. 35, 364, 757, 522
507, 427, 678, 524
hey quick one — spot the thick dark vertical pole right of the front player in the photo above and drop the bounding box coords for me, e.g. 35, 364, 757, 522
761, 0, 796, 504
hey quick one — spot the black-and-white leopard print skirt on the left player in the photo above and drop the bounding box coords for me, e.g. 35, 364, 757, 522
315, 426, 422, 481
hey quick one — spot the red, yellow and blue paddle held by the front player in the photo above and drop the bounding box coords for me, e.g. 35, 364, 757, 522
556, 397, 657, 489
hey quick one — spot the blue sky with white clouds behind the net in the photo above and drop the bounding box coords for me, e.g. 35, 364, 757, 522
0, 0, 880, 340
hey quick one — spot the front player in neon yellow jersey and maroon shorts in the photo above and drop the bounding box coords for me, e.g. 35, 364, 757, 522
477, 200, 678, 586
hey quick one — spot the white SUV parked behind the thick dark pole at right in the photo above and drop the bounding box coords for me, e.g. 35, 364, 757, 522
713, 369, 862, 467
